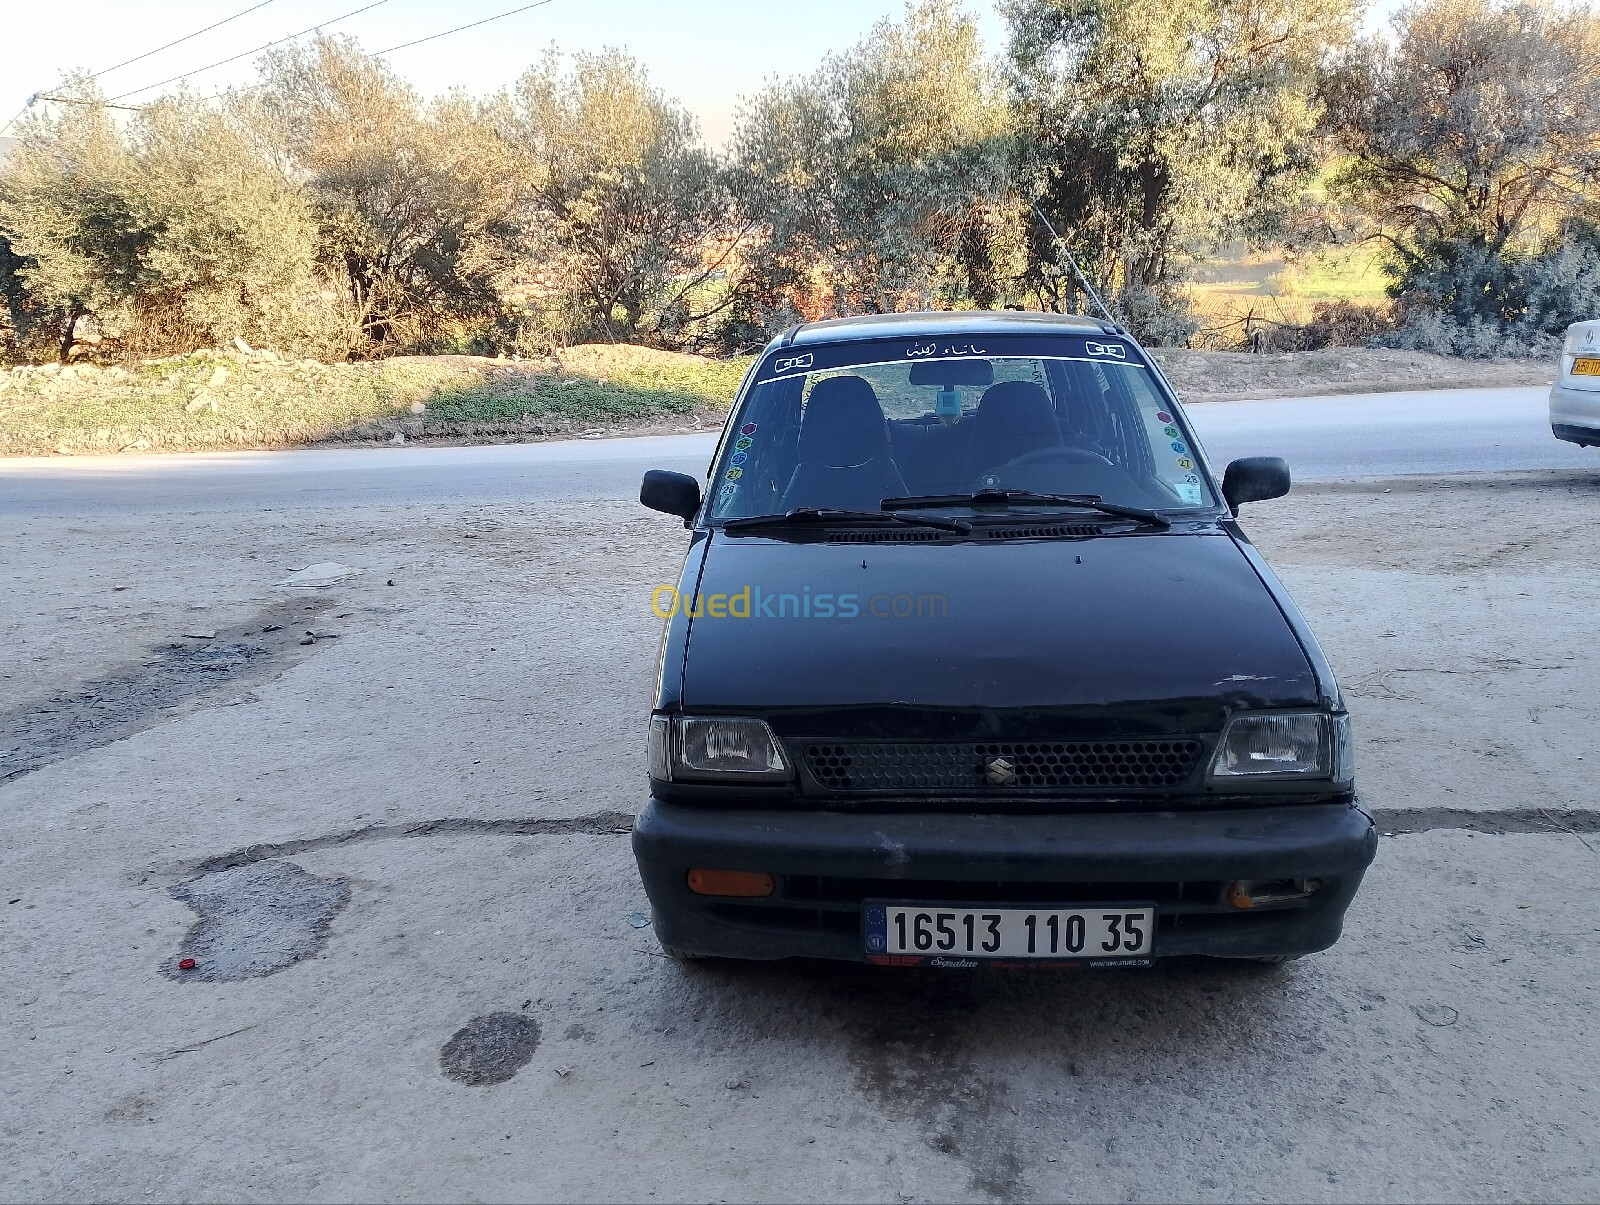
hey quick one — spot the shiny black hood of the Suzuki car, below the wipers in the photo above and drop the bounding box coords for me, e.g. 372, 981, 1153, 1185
682, 528, 1318, 739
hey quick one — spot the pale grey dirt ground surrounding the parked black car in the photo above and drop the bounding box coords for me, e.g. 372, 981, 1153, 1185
0, 474, 1600, 1202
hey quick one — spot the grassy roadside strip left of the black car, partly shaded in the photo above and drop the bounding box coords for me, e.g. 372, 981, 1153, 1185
0, 346, 749, 456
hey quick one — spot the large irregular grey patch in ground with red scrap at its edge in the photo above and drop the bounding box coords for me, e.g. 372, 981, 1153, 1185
162, 863, 350, 983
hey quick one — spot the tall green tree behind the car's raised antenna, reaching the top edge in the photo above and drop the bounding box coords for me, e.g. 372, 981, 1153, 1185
1002, 0, 1358, 333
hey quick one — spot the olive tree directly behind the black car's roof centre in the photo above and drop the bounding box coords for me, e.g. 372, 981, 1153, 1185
733, 0, 1010, 325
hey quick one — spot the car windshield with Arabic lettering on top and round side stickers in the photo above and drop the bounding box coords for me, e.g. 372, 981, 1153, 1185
710, 336, 1214, 518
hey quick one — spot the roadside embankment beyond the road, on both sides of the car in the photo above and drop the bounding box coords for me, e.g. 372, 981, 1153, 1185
0, 344, 1554, 456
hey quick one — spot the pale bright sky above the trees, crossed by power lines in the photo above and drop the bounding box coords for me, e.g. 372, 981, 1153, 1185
0, 0, 1398, 146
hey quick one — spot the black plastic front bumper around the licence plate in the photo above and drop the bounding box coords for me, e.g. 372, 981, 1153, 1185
634, 799, 1378, 962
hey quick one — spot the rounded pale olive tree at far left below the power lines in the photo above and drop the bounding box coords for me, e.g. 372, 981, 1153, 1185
0, 83, 326, 355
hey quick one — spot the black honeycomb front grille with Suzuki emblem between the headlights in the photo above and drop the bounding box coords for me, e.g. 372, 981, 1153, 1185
805, 738, 1200, 794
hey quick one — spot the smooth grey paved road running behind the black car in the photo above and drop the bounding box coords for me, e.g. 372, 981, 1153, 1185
0, 387, 1600, 515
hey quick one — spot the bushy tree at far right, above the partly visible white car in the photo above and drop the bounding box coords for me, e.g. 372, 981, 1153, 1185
1326, 0, 1600, 354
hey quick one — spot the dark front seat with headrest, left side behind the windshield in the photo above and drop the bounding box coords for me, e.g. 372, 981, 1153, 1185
779, 376, 906, 510
